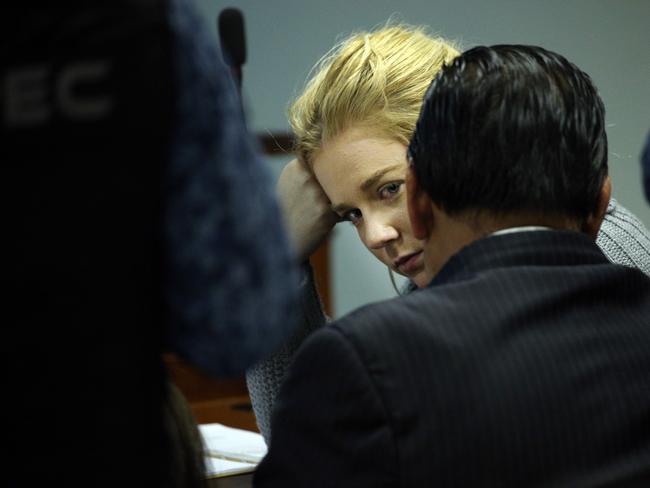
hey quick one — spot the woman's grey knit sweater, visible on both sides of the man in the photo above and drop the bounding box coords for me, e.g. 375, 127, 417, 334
246, 199, 650, 444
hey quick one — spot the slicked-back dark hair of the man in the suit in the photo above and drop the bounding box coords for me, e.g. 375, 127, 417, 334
409, 45, 607, 222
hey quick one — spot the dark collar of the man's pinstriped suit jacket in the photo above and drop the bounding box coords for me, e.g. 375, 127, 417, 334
429, 230, 610, 287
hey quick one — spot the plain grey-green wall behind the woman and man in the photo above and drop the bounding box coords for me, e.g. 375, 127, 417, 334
196, 0, 650, 315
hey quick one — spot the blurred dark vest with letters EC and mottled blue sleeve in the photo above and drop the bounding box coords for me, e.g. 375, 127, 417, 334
0, 0, 297, 487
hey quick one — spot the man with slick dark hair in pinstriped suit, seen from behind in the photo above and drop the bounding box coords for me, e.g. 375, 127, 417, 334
255, 46, 650, 488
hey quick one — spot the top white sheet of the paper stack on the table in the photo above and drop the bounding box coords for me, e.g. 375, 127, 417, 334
199, 424, 266, 465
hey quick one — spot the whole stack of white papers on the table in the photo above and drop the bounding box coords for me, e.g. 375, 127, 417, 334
199, 424, 266, 477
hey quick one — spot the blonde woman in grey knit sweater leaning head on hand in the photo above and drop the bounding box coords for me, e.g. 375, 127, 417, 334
247, 25, 650, 442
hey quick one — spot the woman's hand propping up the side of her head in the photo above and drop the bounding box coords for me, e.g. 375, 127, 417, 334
277, 159, 340, 263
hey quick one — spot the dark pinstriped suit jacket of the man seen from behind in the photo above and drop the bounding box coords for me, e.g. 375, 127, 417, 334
255, 231, 650, 488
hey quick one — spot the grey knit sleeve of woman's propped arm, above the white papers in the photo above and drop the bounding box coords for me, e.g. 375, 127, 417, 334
246, 265, 328, 444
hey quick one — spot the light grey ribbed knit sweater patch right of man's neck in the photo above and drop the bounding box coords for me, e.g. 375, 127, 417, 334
596, 198, 650, 276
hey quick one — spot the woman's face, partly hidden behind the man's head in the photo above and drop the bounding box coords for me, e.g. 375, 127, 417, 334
313, 127, 430, 287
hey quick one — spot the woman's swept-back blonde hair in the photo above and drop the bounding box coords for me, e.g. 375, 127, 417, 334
289, 24, 459, 165
